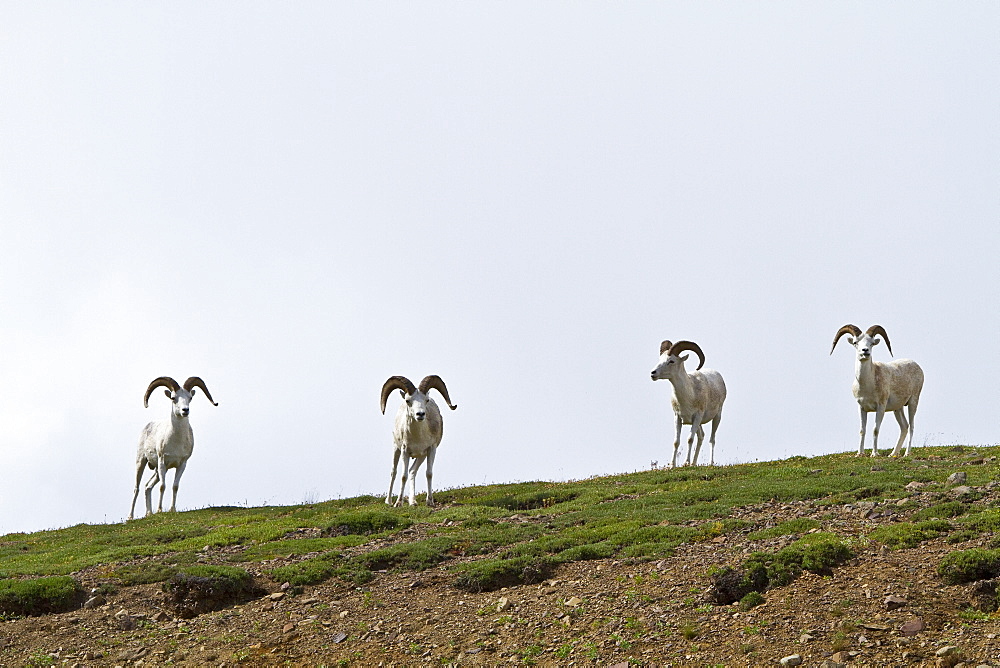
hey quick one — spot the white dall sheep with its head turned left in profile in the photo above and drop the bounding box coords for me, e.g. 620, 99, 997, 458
651, 341, 726, 468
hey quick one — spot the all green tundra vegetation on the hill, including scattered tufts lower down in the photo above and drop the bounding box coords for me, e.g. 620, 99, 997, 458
0, 447, 1000, 662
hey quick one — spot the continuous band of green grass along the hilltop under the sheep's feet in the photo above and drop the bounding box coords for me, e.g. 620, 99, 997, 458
0, 447, 1000, 598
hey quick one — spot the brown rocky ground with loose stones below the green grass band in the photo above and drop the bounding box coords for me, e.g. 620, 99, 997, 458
0, 480, 1000, 667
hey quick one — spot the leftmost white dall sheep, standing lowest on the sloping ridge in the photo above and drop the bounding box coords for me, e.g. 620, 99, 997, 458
128, 376, 219, 519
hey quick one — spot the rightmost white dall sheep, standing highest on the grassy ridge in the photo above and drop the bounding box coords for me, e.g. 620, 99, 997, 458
830, 325, 924, 457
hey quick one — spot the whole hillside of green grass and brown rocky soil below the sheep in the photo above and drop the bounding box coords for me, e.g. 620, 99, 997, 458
0, 447, 1000, 666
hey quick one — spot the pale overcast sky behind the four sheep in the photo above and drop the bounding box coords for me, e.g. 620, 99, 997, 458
0, 1, 1000, 533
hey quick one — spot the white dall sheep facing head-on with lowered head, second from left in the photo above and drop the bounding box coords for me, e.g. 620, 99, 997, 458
382, 376, 458, 506
